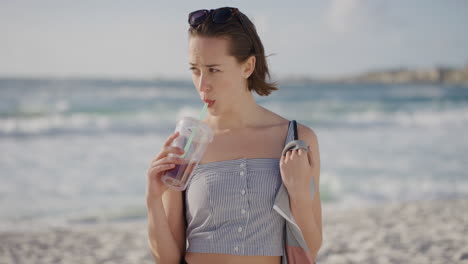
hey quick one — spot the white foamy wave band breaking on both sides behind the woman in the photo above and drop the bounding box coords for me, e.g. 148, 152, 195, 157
0, 101, 468, 136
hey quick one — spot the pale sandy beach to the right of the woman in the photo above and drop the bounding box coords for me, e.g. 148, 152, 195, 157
318, 198, 468, 264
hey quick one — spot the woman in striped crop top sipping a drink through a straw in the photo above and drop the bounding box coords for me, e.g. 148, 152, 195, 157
147, 7, 322, 264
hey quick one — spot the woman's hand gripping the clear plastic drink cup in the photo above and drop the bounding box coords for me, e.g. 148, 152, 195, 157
146, 131, 184, 203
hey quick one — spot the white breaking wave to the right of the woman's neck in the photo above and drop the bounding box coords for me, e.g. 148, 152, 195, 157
265, 101, 468, 127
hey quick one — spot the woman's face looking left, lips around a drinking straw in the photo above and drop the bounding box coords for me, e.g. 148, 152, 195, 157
189, 37, 250, 115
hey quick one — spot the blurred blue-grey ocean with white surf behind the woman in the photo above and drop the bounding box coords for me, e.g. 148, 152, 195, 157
0, 78, 468, 229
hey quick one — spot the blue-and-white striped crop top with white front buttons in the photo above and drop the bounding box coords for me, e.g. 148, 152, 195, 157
185, 122, 294, 256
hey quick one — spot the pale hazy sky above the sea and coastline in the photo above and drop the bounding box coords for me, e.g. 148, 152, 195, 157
0, 0, 468, 79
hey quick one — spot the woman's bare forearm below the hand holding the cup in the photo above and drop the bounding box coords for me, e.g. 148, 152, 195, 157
147, 199, 182, 264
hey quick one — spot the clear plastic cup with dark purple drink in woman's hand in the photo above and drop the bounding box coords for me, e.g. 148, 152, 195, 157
162, 116, 213, 191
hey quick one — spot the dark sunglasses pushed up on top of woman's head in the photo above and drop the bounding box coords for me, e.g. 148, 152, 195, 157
188, 7, 244, 27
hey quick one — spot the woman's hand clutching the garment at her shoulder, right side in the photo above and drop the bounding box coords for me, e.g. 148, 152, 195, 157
280, 147, 313, 195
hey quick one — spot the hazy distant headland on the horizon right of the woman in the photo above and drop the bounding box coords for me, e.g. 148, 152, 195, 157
280, 64, 468, 85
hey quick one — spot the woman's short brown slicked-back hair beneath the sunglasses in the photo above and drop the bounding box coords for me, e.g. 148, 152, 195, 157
188, 6, 278, 96
